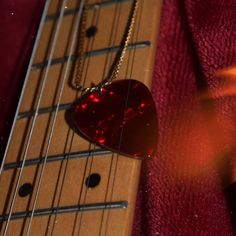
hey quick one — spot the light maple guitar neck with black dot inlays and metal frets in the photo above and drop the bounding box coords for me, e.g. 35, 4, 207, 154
0, 0, 161, 236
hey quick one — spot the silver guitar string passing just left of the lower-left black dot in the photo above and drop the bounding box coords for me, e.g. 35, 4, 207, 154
4, 0, 67, 236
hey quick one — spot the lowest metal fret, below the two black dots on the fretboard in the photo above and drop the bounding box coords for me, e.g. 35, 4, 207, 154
0, 201, 128, 222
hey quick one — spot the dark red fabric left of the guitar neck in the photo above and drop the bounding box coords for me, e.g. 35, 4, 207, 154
0, 0, 43, 153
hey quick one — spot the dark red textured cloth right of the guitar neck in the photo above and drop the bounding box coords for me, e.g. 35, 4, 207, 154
133, 0, 236, 236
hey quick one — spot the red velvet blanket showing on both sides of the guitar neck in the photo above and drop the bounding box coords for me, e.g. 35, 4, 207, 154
0, 0, 236, 236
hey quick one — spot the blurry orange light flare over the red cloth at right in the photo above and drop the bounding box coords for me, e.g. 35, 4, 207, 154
167, 66, 236, 179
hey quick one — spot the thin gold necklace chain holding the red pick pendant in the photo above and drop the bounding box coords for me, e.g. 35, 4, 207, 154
74, 0, 139, 93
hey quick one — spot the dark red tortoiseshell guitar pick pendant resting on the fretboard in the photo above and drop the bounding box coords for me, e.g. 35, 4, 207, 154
74, 79, 158, 159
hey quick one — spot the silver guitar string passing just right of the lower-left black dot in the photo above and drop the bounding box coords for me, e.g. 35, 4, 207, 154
24, 0, 85, 236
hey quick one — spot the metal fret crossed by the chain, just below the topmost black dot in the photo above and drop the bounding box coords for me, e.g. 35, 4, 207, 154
32, 41, 151, 70
